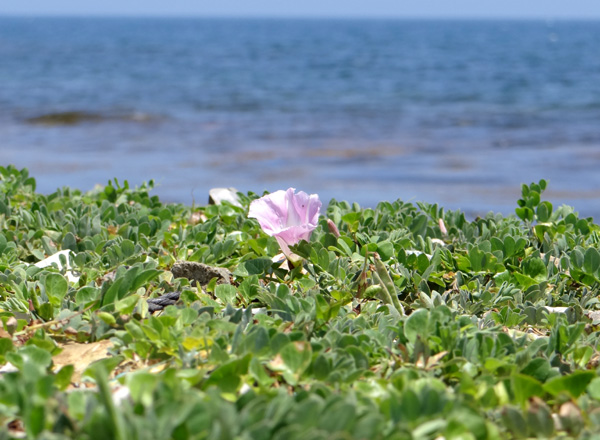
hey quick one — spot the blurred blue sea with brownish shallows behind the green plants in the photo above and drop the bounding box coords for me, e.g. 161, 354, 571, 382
0, 17, 600, 219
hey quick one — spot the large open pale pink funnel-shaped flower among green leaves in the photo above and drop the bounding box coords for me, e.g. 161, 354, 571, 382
248, 188, 321, 257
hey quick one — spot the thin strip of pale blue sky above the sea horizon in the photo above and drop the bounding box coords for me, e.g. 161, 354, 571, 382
0, 0, 600, 19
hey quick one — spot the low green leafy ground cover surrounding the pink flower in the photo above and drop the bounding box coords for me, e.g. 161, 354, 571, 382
0, 166, 600, 440
